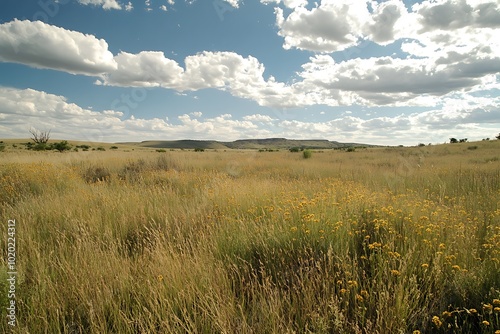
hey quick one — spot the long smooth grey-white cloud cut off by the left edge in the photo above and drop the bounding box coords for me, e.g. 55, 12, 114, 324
0, 20, 117, 75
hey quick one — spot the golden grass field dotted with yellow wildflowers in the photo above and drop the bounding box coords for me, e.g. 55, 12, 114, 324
0, 140, 500, 334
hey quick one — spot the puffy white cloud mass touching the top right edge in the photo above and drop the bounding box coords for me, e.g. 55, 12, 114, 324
272, 0, 500, 53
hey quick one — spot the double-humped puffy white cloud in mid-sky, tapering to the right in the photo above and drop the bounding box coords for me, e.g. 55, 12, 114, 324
97, 51, 304, 106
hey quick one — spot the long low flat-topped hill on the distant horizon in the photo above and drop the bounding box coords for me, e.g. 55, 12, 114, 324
122, 138, 374, 150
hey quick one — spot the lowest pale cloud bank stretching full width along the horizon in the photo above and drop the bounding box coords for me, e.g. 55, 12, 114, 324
0, 87, 500, 145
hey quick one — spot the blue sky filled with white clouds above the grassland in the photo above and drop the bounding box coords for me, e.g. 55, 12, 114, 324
0, 0, 500, 145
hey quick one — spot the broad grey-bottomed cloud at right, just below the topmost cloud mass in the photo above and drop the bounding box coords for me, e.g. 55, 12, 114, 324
296, 45, 500, 106
